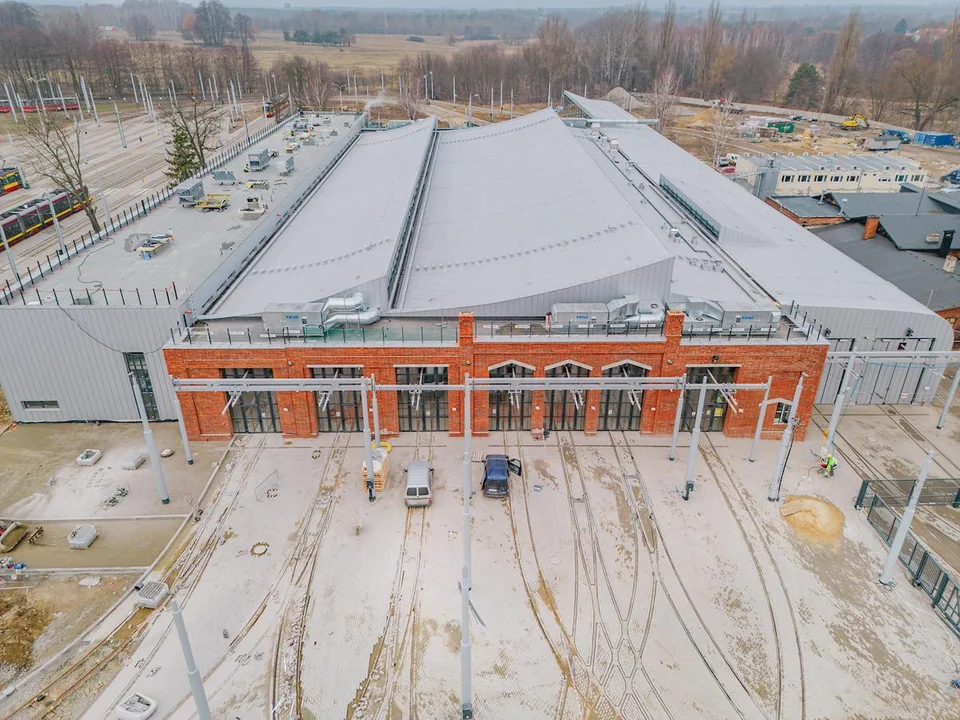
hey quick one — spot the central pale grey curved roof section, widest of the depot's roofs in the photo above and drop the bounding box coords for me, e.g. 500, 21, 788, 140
401, 110, 673, 314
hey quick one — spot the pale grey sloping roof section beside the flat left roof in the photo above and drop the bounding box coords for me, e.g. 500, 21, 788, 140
210, 118, 436, 317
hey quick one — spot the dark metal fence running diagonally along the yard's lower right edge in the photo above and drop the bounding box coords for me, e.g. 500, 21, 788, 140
867, 495, 960, 638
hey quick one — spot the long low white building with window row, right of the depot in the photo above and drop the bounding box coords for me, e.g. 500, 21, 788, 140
736, 153, 927, 198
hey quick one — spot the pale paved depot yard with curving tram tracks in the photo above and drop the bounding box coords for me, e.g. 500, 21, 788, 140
0, 407, 960, 718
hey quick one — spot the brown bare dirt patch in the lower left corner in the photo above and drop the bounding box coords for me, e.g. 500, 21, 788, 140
0, 576, 133, 685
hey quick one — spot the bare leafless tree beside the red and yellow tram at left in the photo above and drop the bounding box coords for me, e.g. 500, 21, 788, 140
26, 115, 100, 232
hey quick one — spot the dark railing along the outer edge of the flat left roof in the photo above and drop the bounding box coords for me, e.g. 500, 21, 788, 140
0, 116, 292, 305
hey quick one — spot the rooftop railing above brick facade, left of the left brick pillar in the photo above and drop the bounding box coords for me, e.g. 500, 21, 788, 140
170, 323, 459, 345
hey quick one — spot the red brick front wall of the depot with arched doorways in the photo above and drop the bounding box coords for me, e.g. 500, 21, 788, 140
164, 313, 827, 440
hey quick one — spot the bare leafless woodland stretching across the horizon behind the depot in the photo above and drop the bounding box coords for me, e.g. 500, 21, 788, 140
0, 0, 960, 130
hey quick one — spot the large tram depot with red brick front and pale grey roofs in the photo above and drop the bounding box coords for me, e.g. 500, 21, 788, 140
0, 93, 953, 439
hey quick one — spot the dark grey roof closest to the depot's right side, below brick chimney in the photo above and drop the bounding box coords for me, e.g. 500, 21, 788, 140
817, 223, 960, 310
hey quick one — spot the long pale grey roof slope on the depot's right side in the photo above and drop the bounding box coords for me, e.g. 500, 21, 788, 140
604, 125, 944, 312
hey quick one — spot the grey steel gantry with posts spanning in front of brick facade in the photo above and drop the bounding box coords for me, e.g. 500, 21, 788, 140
171, 374, 776, 718
